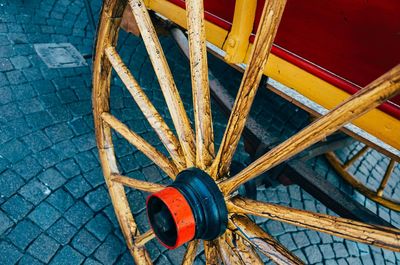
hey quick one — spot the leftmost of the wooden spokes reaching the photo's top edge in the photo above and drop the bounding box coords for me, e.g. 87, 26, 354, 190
129, 0, 196, 167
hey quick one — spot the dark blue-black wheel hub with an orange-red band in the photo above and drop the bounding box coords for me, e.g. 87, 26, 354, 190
147, 168, 228, 249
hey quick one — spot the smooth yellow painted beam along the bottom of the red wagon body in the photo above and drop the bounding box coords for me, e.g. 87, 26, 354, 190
148, 0, 400, 149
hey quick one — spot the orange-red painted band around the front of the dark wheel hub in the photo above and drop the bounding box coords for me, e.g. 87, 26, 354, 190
146, 187, 196, 249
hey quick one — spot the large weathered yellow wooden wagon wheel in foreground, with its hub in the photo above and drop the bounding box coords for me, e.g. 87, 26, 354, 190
93, 0, 400, 264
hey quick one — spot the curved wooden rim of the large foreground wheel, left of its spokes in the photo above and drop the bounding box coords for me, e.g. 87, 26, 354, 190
92, 0, 151, 264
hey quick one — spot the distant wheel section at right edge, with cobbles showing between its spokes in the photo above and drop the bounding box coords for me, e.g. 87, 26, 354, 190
326, 138, 400, 211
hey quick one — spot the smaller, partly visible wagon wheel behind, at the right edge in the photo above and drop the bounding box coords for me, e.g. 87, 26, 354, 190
325, 144, 400, 211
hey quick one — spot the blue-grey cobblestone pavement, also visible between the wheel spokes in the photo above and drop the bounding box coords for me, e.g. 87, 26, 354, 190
0, 0, 400, 265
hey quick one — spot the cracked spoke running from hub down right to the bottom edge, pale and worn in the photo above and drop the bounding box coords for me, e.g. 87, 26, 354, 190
230, 214, 304, 264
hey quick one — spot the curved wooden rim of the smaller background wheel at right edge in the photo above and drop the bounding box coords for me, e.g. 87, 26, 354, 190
325, 152, 400, 211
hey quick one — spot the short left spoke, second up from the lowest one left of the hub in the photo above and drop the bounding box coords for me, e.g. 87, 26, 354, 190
101, 112, 178, 179
